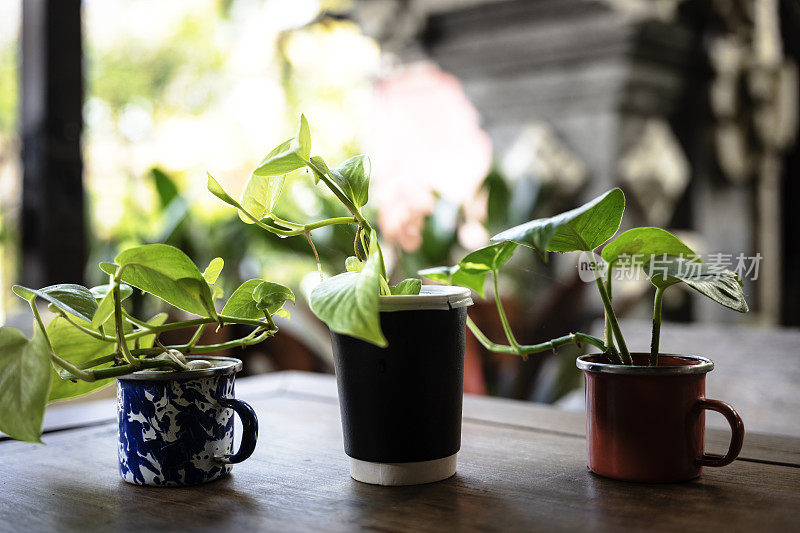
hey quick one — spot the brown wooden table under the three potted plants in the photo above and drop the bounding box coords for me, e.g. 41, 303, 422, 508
0, 372, 800, 533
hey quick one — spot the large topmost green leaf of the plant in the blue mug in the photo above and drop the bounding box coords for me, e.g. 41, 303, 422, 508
109, 244, 217, 319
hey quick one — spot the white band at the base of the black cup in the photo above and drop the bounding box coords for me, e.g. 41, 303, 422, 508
350, 453, 458, 487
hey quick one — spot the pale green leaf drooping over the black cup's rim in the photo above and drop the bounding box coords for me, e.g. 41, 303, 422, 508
310, 234, 389, 347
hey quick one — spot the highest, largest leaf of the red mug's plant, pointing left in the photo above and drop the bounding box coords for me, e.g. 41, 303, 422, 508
492, 188, 625, 260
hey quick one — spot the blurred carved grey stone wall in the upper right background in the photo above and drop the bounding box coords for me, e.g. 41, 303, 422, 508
354, 0, 800, 324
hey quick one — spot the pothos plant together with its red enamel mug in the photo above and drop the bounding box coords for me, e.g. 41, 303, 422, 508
420, 188, 748, 482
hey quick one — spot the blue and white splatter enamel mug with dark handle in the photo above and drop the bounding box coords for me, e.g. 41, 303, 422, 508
117, 356, 258, 487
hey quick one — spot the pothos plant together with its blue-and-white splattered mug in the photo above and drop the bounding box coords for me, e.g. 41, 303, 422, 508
0, 244, 294, 486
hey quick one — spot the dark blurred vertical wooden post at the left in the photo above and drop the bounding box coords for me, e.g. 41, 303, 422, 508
20, 0, 86, 287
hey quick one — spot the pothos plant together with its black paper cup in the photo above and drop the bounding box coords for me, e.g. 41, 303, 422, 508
208, 116, 472, 485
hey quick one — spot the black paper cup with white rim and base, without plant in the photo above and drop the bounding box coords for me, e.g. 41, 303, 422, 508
331, 285, 472, 485
